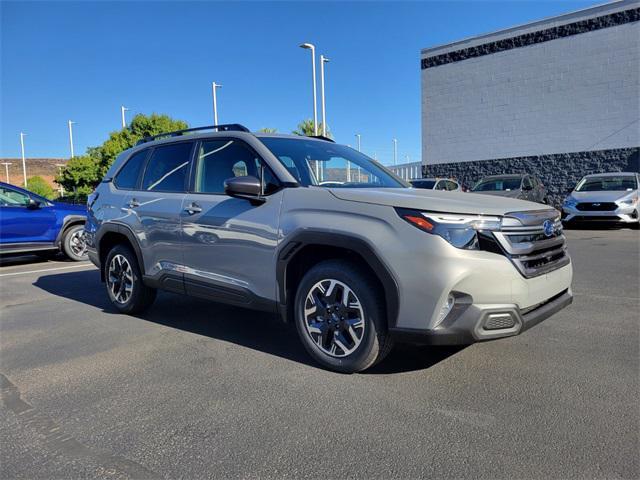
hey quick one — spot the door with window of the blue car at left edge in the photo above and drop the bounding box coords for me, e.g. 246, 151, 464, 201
0, 185, 57, 244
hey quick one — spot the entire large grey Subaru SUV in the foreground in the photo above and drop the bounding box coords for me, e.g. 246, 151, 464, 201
86, 125, 572, 372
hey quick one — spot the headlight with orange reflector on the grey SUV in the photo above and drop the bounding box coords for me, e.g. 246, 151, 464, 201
396, 208, 502, 250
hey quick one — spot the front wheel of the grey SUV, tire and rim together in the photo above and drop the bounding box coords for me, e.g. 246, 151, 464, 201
294, 260, 393, 373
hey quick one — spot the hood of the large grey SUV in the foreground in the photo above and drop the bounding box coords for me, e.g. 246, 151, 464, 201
327, 188, 550, 215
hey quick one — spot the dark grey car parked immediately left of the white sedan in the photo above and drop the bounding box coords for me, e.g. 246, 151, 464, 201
471, 174, 549, 204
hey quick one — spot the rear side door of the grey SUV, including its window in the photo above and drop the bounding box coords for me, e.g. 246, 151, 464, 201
116, 141, 195, 291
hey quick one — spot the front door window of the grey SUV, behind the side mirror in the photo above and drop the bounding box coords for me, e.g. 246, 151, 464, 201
195, 139, 279, 195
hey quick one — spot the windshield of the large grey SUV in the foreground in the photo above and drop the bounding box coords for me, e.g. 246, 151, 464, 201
255, 137, 407, 188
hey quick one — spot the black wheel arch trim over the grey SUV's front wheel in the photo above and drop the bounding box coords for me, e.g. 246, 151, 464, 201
276, 229, 400, 328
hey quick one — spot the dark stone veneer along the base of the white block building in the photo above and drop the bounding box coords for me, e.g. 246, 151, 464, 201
422, 147, 640, 207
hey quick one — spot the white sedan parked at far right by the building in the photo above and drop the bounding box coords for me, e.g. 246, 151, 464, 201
562, 172, 640, 228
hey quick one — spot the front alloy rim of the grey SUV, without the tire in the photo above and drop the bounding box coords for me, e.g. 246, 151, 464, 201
304, 279, 365, 357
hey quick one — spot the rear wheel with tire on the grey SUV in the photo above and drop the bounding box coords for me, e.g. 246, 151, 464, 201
102, 245, 156, 315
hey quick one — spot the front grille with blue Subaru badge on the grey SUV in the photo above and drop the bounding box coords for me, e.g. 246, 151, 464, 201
493, 210, 571, 278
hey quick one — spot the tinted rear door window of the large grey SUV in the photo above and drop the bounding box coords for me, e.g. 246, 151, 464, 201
142, 142, 193, 192
